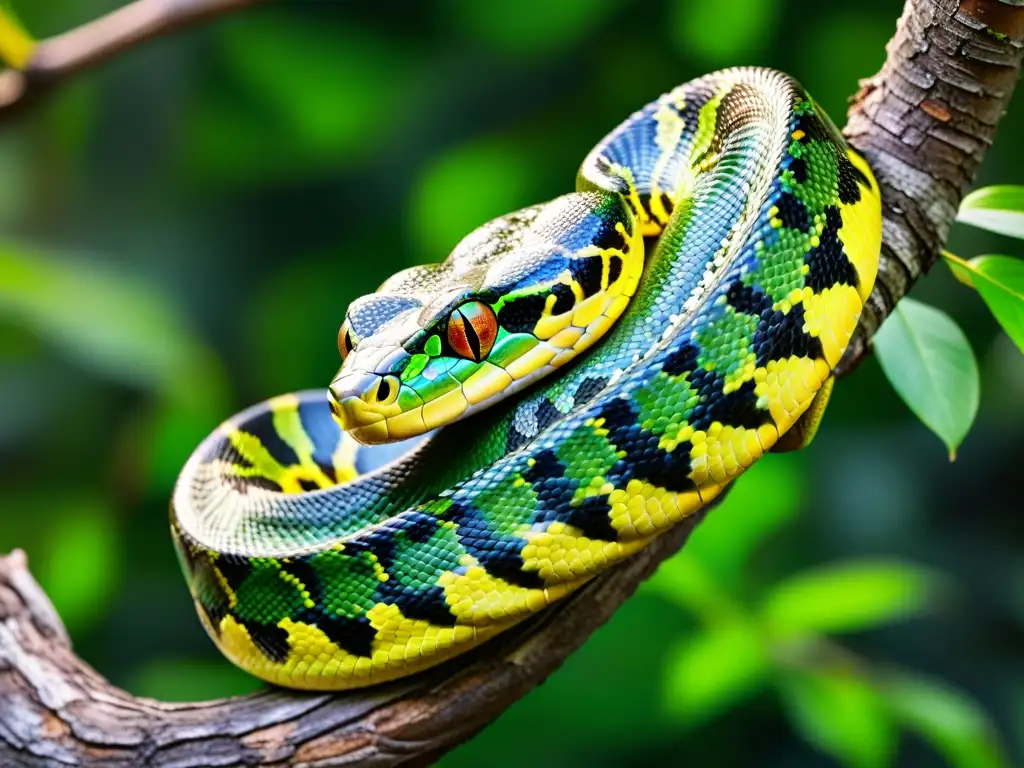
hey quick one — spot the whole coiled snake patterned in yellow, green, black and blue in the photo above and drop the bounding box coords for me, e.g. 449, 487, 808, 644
171, 68, 882, 690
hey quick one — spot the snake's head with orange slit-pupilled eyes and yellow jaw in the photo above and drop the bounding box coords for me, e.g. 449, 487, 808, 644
329, 194, 643, 443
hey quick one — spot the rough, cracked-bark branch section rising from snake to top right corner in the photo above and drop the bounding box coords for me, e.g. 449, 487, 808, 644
840, 0, 1024, 373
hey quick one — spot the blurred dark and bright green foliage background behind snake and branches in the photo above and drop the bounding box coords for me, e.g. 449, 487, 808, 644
0, 0, 1024, 768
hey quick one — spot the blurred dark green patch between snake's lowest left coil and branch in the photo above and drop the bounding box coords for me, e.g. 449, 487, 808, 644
125, 658, 263, 701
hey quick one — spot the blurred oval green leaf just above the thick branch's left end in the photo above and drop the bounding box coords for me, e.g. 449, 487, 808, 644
38, 493, 123, 634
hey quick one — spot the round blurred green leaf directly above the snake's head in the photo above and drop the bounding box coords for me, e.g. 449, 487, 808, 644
411, 139, 538, 261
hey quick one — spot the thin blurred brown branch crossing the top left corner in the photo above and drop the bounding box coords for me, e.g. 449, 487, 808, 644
0, 0, 260, 114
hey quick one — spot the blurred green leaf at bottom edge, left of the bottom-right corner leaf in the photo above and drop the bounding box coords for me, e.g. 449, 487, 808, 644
779, 671, 898, 768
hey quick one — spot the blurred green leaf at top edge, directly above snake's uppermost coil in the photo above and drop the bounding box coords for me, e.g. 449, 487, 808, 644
669, 0, 781, 65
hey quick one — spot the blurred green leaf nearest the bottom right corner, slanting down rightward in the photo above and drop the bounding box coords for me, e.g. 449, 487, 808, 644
884, 675, 1010, 768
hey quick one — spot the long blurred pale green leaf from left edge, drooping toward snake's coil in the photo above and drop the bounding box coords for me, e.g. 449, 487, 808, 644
0, 244, 229, 493
